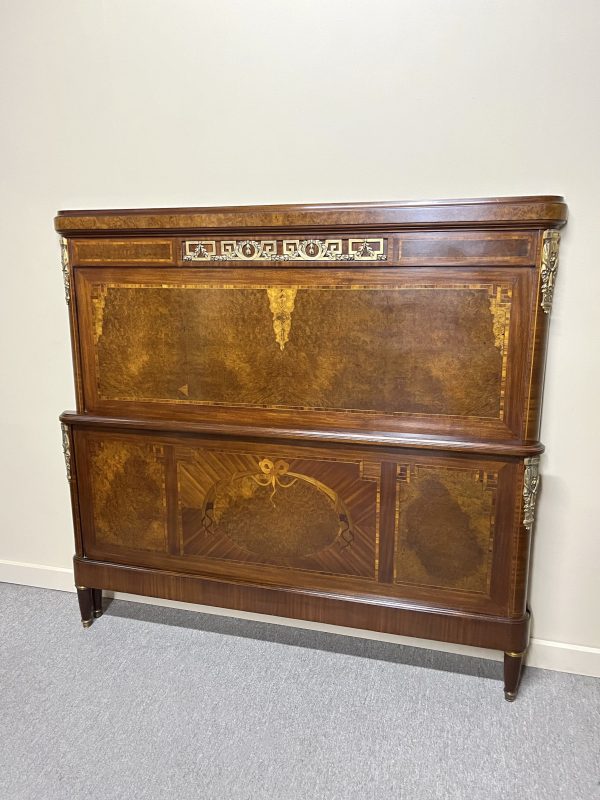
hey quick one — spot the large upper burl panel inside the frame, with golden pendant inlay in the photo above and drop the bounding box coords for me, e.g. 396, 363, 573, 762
83, 273, 513, 421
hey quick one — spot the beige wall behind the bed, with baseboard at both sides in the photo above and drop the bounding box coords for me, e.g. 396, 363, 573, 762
0, 0, 600, 672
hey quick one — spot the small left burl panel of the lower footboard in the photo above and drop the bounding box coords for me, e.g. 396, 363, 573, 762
87, 437, 167, 552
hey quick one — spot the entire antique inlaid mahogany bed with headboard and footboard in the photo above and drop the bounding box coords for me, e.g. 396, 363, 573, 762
55, 196, 567, 700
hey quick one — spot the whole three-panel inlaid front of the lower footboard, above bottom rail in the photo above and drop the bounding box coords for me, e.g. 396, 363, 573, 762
68, 422, 523, 614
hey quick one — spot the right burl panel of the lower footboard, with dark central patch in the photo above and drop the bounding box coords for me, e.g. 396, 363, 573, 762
394, 463, 503, 594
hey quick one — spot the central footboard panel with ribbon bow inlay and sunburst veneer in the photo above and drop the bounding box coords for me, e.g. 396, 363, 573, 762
176, 447, 380, 578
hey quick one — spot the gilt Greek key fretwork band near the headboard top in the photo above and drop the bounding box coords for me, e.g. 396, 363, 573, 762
183, 239, 387, 262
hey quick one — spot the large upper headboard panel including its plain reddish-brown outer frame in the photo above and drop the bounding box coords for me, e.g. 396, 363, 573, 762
75, 267, 536, 440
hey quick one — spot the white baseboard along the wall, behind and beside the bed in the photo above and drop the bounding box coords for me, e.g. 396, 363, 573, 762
0, 560, 600, 678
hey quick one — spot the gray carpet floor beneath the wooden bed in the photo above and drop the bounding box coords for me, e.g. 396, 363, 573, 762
0, 583, 600, 800
